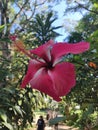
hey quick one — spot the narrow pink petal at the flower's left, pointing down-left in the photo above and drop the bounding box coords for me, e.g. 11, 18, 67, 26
21, 59, 44, 88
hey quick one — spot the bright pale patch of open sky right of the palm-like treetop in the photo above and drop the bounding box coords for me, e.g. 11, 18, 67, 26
53, 1, 82, 42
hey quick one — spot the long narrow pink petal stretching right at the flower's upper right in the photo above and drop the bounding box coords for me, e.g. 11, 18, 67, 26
51, 42, 90, 60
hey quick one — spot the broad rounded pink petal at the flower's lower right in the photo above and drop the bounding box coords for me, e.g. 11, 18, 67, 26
49, 62, 76, 97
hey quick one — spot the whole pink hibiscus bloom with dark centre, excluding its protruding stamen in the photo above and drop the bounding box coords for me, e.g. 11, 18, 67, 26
21, 40, 89, 101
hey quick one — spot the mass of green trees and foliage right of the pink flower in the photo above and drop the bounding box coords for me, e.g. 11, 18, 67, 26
62, 0, 98, 130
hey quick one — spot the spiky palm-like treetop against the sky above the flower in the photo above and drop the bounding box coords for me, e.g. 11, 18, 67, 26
21, 12, 62, 46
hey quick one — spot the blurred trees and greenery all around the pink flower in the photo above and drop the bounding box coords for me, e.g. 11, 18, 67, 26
0, 0, 98, 130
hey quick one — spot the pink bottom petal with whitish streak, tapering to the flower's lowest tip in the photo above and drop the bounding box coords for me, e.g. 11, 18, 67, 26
30, 67, 61, 101
